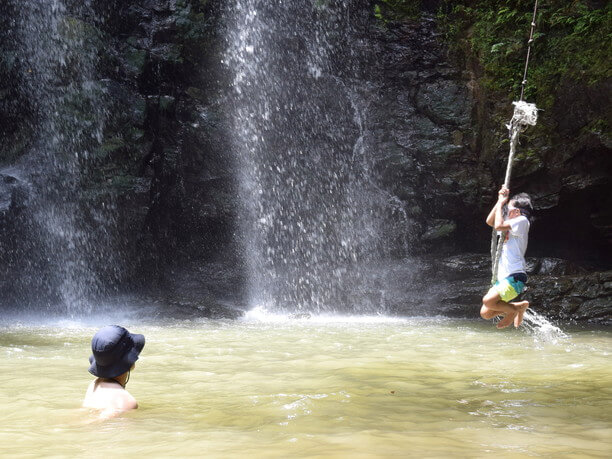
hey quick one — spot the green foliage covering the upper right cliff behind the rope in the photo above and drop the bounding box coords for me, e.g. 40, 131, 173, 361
375, 0, 612, 182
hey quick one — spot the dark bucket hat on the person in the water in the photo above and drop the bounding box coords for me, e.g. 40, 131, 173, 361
89, 325, 144, 378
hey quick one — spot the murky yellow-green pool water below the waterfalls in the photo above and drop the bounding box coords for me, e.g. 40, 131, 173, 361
0, 319, 612, 458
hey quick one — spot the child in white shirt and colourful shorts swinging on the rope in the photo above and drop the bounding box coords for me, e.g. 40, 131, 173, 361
480, 186, 533, 328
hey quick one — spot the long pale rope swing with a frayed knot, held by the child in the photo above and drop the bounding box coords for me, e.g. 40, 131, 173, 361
491, 0, 538, 285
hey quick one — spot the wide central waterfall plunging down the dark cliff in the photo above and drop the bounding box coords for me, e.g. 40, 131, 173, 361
224, 0, 384, 313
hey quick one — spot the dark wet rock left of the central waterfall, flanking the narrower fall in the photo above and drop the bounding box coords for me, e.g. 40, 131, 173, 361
0, 0, 240, 312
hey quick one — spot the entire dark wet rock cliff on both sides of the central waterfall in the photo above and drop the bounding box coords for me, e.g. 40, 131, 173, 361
0, 0, 612, 323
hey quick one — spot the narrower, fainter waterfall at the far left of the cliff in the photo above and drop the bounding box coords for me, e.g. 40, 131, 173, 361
2, 0, 114, 315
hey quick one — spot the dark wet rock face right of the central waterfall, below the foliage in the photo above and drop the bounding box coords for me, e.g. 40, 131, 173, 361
358, 13, 612, 323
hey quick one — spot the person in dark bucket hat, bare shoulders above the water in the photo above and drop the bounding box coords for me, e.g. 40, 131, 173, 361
83, 325, 145, 417
